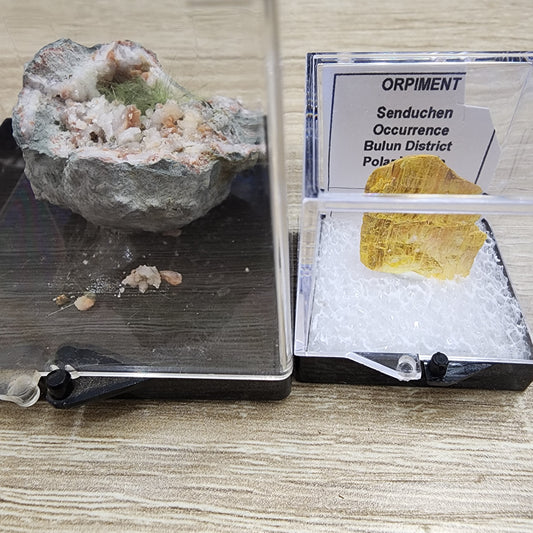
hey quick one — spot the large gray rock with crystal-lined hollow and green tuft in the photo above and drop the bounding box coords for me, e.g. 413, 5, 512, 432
13, 39, 265, 232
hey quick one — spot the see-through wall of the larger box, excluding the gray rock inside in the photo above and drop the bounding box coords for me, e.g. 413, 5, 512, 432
0, 0, 291, 404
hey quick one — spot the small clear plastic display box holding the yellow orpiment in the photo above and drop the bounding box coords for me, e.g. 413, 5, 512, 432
294, 52, 533, 390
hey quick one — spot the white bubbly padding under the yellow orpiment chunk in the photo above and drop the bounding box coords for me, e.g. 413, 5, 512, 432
308, 213, 530, 359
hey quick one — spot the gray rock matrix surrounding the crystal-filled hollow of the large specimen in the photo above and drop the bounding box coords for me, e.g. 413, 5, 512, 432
13, 39, 265, 232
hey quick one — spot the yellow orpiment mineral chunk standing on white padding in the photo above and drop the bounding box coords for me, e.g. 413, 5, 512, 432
360, 155, 487, 279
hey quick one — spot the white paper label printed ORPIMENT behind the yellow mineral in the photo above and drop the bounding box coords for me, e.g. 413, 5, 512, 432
320, 63, 500, 191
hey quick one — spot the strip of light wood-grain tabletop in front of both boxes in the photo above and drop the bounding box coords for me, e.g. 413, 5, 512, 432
0, 385, 533, 532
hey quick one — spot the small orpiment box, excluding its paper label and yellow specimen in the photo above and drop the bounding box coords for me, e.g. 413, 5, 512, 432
295, 53, 533, 388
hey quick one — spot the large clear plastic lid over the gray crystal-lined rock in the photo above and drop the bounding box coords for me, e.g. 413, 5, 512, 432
0, 0, 291, 405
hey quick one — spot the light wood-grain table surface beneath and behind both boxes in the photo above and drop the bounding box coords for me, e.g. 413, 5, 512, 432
0, 0, 533, 532
